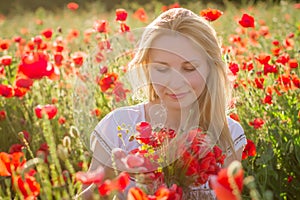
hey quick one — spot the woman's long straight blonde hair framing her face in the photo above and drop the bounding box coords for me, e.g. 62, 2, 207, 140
129, 8, 236, 158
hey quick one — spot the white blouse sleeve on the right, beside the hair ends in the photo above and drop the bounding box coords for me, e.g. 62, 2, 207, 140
227, 117, 247, 151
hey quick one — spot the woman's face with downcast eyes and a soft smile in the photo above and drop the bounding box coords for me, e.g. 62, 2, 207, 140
148, 34, 209, 109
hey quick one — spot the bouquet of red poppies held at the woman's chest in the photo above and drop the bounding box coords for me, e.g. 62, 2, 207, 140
124, 122, 225, 198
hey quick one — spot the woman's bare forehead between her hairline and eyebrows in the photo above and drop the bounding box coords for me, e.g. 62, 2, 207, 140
149, 34, 206, 61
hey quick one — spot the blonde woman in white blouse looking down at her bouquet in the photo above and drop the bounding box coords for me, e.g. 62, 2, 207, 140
84, 8, 246, 199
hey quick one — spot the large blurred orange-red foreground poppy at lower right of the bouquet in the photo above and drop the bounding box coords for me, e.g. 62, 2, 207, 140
210, 161, 244, 200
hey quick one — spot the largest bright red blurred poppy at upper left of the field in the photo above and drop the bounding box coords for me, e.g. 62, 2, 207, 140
19, 52, 54, 79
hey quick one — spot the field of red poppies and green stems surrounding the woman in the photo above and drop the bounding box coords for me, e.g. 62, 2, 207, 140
0, 1, 300, 200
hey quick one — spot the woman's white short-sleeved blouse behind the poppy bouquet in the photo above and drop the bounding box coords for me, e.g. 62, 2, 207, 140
90, 103, 247, 199
